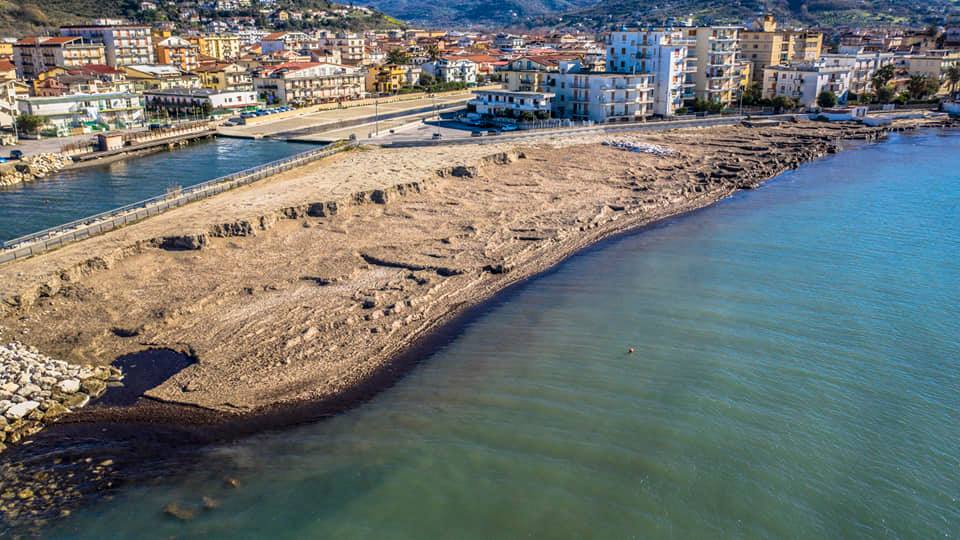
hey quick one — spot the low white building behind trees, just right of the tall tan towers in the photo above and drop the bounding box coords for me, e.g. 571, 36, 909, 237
763, 62, 850, 107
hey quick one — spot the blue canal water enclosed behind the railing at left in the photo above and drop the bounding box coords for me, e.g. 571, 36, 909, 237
0, 138, 313, 242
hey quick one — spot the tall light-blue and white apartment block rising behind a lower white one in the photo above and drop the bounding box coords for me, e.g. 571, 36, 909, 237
606, 29, 696, 116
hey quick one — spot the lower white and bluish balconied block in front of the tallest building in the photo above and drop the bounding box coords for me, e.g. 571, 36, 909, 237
546, 62, 655, 123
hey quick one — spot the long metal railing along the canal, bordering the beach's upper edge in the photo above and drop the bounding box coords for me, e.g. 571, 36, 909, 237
0, 141, 357, 264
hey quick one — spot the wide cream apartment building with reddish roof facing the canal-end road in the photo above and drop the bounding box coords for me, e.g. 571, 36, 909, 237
253, 62, 364, 106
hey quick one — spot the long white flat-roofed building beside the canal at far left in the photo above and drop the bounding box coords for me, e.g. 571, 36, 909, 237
17, 92, 144, 136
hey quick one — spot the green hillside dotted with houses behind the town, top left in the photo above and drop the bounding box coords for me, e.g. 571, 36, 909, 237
0, 0, 400, 37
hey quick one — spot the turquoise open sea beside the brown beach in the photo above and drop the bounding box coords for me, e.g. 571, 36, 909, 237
41, 131, 960, 539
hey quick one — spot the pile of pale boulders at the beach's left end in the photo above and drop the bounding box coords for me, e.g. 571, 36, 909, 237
0, 342, 122, 451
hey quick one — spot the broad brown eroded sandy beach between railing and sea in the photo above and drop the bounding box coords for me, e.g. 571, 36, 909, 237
0, 120, 941, 415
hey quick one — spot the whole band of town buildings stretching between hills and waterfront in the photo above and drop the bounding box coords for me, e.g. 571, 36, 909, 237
0, 11, 960, 141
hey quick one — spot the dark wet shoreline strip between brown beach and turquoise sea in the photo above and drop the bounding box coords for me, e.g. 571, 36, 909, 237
0, 117, 956, 440
